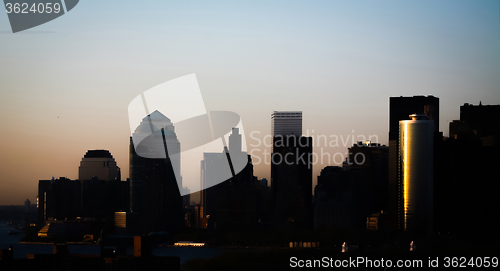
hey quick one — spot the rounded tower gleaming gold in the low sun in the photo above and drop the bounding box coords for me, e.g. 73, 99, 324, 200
398, 114, 434, 234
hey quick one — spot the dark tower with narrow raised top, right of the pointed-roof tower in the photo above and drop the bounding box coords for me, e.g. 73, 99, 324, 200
200, 128, 261, 228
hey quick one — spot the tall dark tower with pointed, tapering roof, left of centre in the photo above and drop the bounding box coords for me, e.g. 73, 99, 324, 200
129, 111, 183, 232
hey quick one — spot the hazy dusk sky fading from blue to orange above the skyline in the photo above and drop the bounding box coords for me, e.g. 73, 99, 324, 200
0, 0, 500, 205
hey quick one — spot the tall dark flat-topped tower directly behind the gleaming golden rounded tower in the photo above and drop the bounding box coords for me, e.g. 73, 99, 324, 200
386, 95, 439, 228
